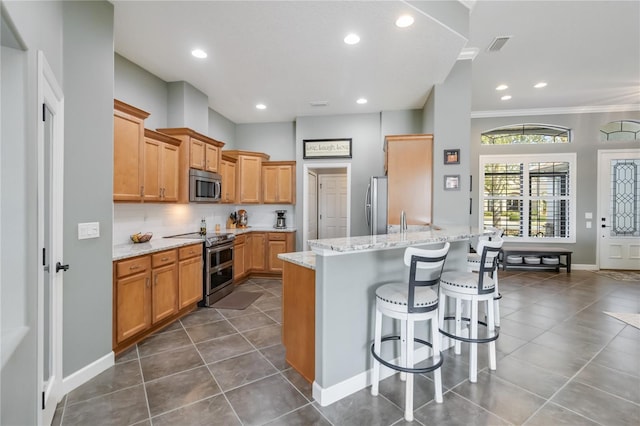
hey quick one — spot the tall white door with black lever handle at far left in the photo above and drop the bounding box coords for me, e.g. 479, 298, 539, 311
36, 52, 68, 425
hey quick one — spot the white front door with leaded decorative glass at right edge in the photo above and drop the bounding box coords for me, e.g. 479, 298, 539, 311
596, 149, 640, 270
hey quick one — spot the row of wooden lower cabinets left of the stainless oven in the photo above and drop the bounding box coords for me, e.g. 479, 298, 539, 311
112, 243, 202, 354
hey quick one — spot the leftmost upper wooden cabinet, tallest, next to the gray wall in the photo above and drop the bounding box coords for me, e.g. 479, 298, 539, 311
113, 99, 149, 201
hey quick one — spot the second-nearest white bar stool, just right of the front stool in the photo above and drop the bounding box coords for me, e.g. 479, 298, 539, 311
438, 237, 503, 383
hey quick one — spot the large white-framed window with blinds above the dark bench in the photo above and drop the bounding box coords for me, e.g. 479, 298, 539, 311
480, 153, 576, 242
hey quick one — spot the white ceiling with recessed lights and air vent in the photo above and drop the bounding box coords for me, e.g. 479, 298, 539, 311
113, 0, 640, 123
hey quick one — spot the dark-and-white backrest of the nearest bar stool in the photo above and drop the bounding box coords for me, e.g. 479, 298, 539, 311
404, 243, 450, 313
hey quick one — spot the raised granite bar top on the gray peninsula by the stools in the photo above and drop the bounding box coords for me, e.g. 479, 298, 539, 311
308, 226, 482, 256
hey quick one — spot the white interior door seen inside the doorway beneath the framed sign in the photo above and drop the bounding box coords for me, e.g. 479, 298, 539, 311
318, 175, 347, 238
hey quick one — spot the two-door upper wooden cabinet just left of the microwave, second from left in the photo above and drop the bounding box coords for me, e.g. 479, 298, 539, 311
143, 129, 181, 202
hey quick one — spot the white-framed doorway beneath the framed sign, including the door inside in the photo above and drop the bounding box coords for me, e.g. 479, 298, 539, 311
302, 163, 351, 250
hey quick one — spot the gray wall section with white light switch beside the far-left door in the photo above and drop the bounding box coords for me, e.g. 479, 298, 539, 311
62, 1, 114, 376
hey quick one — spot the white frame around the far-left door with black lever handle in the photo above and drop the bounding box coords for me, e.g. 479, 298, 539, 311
36, 51, 64, 425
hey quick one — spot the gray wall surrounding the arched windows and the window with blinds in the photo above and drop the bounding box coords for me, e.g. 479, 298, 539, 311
470, 111, 640, 265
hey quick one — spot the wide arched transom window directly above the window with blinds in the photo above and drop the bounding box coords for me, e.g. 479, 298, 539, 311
480, 123, 571, 145
